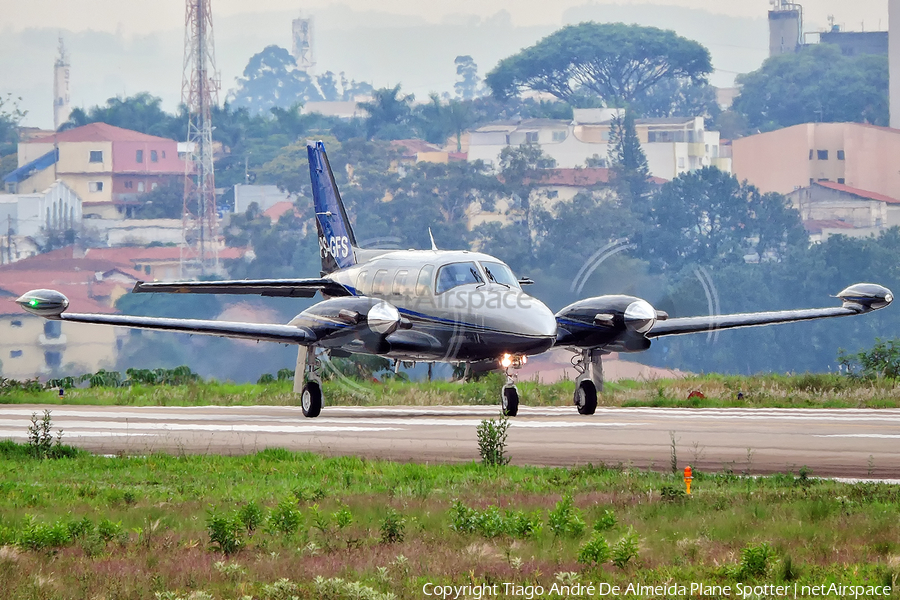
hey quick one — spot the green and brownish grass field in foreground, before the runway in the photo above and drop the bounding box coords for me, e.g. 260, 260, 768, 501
0, 442, 900, 600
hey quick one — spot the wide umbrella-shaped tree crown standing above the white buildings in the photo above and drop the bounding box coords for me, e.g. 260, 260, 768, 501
486, 22, 712, 106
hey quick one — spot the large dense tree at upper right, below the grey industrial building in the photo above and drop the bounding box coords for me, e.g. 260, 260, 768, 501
734, 44, 888, 131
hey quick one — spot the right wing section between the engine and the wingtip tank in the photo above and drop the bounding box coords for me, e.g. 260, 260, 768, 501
644, 306, 863, 338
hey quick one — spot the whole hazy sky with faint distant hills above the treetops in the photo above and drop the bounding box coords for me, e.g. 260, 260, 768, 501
0, 0, 888, 127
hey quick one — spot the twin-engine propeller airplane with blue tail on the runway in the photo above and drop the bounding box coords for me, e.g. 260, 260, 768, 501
16, 141, 893, 417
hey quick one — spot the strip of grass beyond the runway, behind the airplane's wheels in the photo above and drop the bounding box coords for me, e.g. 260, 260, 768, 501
0, 374, 900, 408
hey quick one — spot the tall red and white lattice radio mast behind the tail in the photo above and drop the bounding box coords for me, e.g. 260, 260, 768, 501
181, 0, 220, 277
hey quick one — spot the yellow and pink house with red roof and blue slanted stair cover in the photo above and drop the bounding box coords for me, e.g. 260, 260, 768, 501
3, 123, 185, 219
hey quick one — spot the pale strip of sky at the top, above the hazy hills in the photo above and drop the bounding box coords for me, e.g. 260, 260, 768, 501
0, 0, 887, 35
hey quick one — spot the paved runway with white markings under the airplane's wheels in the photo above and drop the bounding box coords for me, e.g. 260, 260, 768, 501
0, 405, 900, 479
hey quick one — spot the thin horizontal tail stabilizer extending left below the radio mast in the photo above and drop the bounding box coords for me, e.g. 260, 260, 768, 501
131, 279, 352, 298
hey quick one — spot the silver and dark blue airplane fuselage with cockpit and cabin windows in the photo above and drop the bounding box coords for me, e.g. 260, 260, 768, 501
297, 250, 556, 362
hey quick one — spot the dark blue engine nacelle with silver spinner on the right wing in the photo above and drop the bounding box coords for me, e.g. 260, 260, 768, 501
556, 295, 666, 352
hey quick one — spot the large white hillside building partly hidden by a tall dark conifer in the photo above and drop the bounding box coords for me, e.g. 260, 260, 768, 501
468, 108, 731, 180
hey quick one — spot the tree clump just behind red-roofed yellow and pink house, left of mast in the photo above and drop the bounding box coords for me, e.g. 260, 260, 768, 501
59, 92, 187, 140
